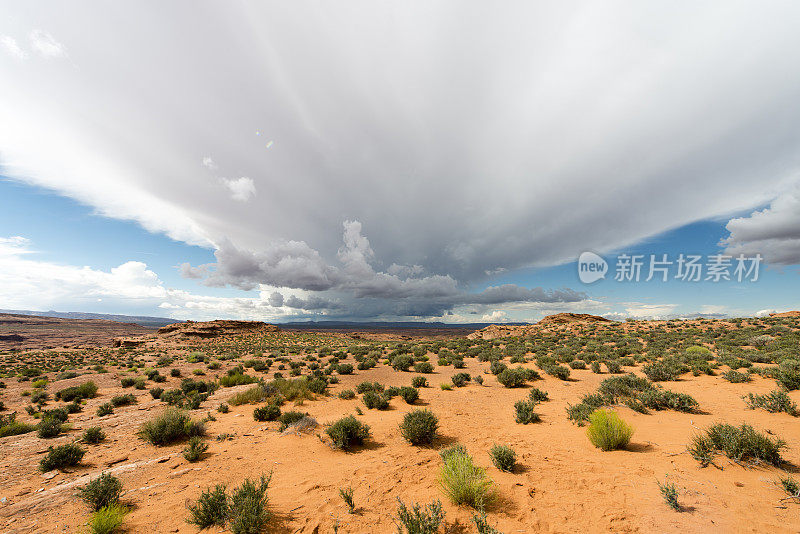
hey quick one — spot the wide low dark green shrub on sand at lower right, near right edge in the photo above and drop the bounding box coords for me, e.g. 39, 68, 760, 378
689, 423, 786, 466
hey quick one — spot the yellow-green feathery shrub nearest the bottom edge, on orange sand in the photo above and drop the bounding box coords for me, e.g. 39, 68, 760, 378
439, 452, 494, 510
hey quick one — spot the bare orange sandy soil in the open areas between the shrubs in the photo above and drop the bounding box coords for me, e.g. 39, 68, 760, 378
0, 344, 800, 533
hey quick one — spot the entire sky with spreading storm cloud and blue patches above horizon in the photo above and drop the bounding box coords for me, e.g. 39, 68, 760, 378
0, 0, 800, 322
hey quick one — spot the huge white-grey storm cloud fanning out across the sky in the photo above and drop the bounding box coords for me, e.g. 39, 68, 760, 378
0, 0, 800, 313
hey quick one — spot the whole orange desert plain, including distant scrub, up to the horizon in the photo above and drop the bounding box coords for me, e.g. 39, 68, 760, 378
0, 316, 800, 533
